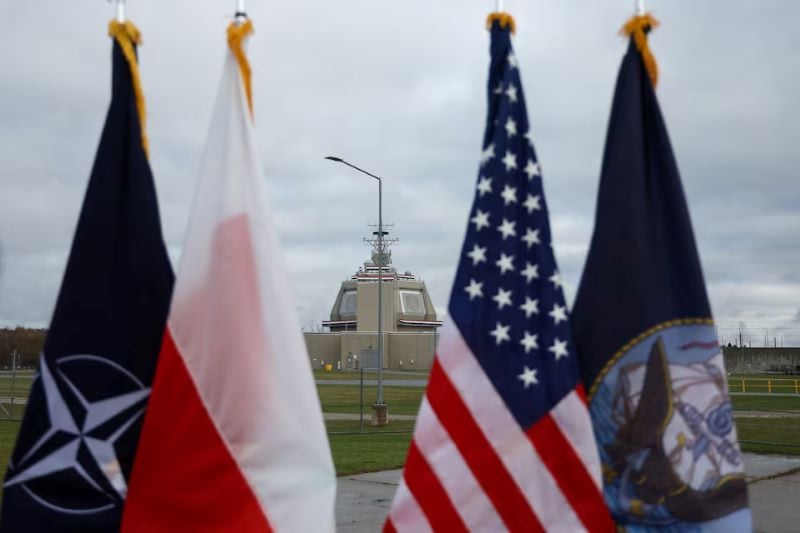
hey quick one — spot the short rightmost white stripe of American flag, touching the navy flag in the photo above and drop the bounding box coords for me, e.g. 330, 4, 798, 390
550, 391, 603, 493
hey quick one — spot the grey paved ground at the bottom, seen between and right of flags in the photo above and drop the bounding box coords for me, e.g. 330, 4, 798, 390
336, 454, 800, 533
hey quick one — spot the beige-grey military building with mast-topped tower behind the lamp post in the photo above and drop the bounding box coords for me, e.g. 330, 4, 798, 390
305, 233, 442, 370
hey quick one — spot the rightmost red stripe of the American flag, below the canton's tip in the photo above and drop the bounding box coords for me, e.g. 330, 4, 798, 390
528, 415, 615, 532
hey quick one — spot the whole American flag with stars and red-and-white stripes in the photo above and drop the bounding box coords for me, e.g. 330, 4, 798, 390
384, 15, 614, 531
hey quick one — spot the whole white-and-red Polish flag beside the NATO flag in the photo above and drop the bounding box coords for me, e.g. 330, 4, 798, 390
123, 22, 336, 532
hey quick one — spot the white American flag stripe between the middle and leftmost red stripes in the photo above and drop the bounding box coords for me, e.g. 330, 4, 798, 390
414, 398, 506, 531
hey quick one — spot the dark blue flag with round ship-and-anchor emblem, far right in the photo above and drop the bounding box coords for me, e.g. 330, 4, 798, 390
572, 17, 751, 531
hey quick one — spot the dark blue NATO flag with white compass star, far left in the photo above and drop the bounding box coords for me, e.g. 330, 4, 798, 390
0, 25, 173, 532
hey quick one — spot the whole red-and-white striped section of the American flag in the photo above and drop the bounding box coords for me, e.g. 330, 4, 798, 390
384, 319, 614, 532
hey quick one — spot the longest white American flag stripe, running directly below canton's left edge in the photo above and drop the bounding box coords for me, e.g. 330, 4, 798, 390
437, 317, 585, 531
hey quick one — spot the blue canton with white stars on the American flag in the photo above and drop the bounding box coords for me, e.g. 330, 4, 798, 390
449, 22, 578, 429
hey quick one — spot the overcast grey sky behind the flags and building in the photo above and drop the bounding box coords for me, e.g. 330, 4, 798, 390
0, 0, 800, 346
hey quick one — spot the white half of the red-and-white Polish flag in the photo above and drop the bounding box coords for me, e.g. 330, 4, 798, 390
169, 48, 336, 531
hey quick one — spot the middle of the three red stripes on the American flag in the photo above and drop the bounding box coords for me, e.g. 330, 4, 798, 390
424, 358, 544, 531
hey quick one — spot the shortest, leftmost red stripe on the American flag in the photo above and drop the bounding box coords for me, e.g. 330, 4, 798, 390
403, 441, 467, 532
